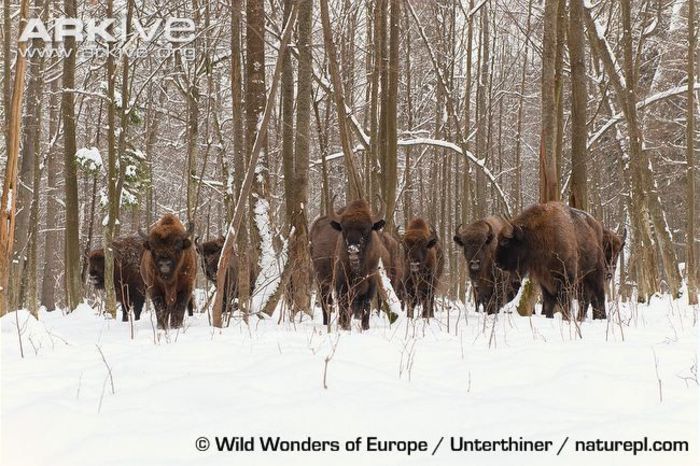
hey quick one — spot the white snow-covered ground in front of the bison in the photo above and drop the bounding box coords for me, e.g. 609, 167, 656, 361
0, 297, 700, 466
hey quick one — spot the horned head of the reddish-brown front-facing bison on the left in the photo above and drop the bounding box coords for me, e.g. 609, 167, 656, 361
139, 222, 194, 282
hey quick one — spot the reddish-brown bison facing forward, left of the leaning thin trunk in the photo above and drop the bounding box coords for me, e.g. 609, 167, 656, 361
139, 214, 197, 329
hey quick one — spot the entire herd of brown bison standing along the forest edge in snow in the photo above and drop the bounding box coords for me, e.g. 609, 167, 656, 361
89, 200, 626, 329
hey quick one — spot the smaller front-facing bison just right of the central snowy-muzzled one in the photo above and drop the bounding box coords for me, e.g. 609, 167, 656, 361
402, 218, 445, 318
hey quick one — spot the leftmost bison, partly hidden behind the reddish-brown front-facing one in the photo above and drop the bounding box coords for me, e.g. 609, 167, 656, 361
88, 236, 146, 322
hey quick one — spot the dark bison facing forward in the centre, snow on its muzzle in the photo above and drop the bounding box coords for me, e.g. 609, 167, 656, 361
330, 199, 391, 330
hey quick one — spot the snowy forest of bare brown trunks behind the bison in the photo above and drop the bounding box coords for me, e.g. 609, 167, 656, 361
0, 0, 700, 315
